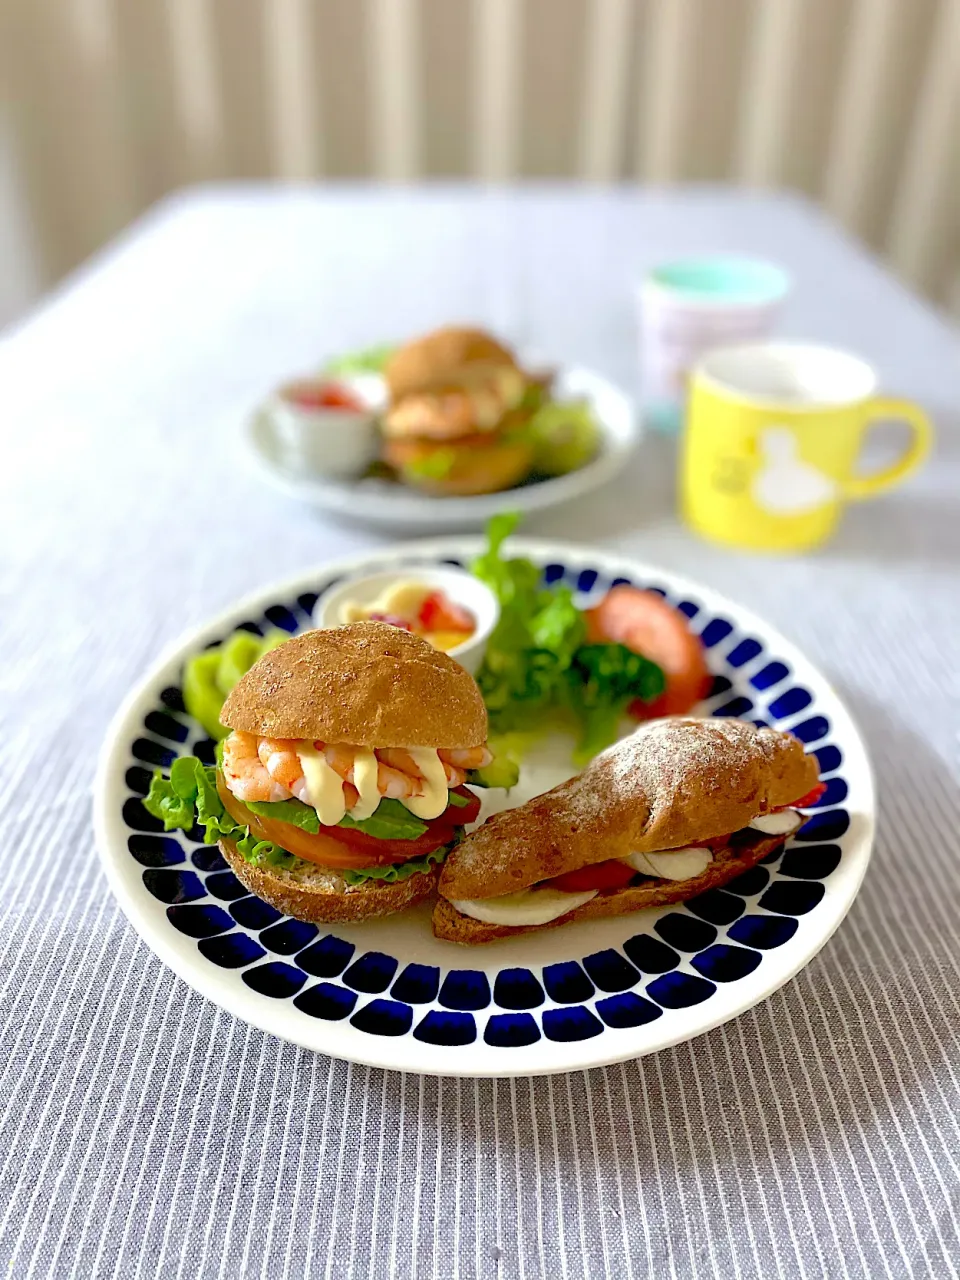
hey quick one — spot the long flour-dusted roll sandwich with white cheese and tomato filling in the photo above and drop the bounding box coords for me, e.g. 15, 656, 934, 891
434, 718, 823, 943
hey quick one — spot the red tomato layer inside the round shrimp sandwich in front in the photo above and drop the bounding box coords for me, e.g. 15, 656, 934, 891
216, 774, 480, 869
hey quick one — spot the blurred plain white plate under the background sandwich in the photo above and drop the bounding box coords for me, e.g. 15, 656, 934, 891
243, 369, 639, 532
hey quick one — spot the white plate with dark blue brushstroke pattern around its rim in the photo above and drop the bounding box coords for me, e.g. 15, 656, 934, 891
95, 539, 874, 1076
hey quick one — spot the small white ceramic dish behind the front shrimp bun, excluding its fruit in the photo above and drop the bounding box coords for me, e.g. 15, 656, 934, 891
314, 564, 500, 673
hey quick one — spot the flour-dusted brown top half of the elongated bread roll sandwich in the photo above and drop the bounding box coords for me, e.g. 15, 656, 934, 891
439, 718, 818, 899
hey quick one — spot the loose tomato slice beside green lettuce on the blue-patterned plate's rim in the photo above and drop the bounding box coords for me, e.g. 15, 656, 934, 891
585, 584, 710, 719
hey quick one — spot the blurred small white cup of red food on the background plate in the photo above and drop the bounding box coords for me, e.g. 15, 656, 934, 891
261, 378, 380, 481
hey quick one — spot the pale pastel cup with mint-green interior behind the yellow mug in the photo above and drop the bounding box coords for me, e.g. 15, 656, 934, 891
639, 256, 790, 431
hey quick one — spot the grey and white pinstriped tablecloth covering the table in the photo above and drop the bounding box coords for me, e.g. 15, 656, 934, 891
0, 188, 960, 1280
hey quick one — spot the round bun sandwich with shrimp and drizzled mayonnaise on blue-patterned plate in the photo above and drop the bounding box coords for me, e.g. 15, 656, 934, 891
209, 622, 490, 922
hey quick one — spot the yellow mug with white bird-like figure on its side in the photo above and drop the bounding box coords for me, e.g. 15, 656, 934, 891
681, 342, 933, 552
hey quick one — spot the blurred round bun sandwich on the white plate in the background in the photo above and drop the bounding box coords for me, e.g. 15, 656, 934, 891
381, 326, 534, 495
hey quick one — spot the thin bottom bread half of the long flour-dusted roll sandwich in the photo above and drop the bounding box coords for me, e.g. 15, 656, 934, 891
434, 836, 783, 946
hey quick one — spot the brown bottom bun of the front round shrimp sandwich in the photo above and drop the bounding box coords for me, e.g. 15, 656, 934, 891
219, 840, 436, 924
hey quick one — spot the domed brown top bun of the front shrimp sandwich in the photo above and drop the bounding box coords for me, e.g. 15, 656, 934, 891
220, 622, 486, 750
